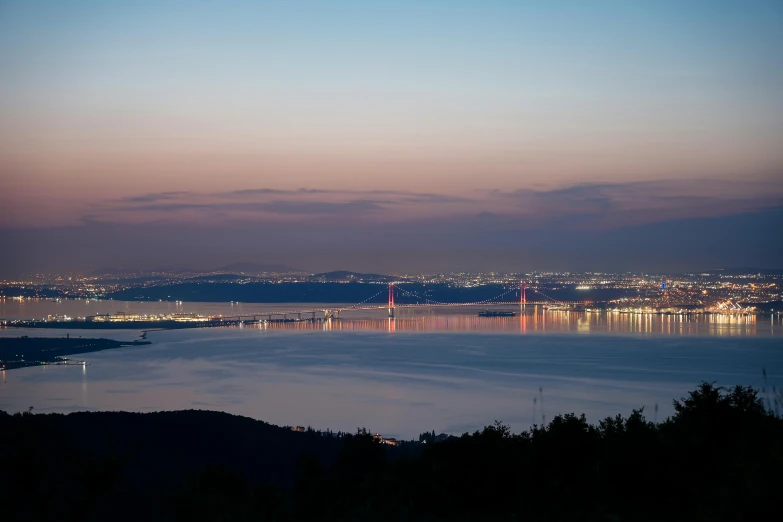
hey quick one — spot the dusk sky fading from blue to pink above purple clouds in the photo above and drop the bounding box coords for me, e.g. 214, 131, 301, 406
0, 0, 783, 277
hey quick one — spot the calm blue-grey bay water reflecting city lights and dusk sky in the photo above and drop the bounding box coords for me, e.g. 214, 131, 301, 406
0, 301, 783, 438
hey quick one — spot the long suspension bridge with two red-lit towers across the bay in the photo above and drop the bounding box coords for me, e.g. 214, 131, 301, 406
210, 282, 590, 322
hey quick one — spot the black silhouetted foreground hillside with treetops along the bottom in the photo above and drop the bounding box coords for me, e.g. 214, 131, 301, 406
0, 383, 783, 521
